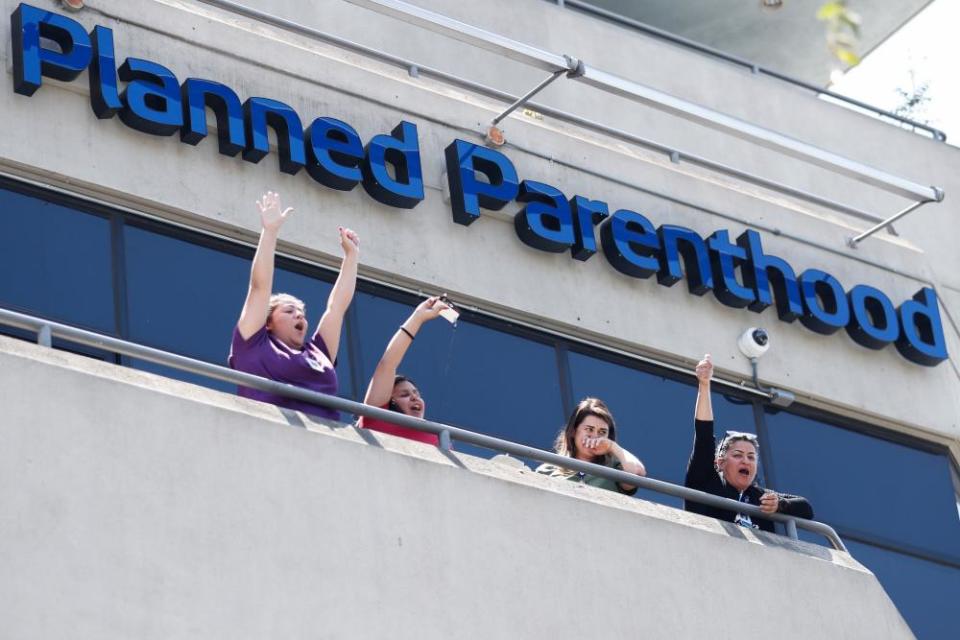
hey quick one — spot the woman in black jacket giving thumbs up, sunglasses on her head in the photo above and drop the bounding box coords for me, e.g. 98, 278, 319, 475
684, 354, 813, 533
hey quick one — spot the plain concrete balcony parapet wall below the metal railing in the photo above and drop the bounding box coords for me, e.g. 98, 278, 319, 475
0, 338, 912, 640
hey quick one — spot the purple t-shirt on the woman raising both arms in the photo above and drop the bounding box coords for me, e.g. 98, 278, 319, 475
227, 327, 340, 420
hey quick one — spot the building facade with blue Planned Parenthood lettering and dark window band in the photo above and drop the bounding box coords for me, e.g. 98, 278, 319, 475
0, 0, 960, 637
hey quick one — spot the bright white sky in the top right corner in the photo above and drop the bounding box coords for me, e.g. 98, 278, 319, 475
830, 0, 960, 146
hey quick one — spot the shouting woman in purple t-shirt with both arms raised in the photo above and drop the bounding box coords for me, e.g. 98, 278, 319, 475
228, 191, 360, 420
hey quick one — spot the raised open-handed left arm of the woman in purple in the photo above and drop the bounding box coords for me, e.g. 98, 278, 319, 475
237, 191, 293, 340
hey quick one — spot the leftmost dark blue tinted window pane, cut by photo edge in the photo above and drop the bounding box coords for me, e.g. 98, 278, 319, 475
0, 190, 116, 334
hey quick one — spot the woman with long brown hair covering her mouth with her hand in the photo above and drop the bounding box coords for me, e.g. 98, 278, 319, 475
537, 398, 647, 496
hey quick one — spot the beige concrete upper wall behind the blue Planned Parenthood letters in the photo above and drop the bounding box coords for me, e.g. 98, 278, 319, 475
0, 0, 960, 444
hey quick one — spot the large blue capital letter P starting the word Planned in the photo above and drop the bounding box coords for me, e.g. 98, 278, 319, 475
10, 4, 92, 96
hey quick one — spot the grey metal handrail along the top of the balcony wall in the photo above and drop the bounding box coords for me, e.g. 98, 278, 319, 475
0, 309, 847, 552
